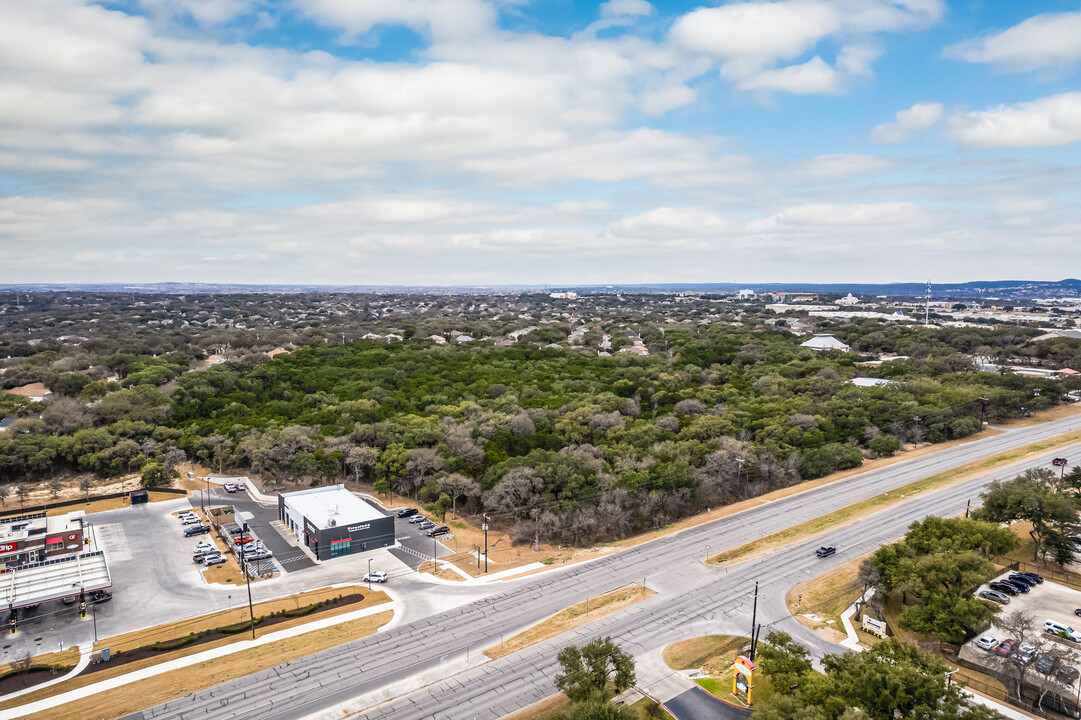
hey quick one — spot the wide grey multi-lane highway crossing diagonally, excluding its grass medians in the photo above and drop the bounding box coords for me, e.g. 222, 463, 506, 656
118, 408, 1081, 720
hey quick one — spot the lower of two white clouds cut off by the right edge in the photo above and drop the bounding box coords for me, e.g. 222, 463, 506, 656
949, 92, 1081, 147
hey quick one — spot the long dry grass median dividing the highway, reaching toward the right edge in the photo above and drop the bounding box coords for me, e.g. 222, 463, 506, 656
707, 431, 1081, 565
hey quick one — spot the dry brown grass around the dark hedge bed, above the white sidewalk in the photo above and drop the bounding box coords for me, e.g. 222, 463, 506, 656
0, 587, 391, 709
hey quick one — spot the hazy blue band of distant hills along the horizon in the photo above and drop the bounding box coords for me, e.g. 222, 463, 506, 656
0, 278, 1081, 299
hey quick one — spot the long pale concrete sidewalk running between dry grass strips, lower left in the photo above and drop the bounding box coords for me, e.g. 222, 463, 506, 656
0, 601, 398, 720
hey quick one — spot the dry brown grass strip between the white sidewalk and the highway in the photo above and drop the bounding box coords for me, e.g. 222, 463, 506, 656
18, 610, 393, 720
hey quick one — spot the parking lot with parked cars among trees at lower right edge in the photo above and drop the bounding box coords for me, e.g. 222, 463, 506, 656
961, 572, 1081, 693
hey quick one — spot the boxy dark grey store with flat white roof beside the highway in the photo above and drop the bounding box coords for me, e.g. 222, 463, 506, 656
278, 485, 395, 560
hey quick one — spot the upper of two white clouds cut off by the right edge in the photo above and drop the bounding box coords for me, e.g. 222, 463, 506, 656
945, 12, 1081, 71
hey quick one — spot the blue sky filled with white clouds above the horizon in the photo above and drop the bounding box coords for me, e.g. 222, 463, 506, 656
0, 0, 1081, 285
